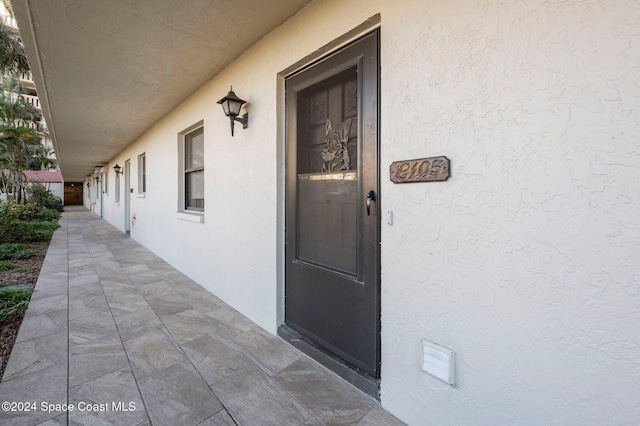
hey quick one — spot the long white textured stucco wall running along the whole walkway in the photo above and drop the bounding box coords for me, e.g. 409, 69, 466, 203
96, 0, 640, 425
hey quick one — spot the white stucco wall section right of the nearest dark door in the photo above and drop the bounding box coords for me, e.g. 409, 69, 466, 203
382, 1, 640, 425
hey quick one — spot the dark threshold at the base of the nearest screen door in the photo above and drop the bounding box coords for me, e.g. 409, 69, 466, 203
278, 325, 380, 401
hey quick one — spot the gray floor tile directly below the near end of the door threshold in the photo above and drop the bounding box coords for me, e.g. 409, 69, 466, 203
275, 358, 376, 424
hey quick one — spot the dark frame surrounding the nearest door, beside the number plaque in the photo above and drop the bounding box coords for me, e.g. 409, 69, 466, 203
277, 25, 382, 399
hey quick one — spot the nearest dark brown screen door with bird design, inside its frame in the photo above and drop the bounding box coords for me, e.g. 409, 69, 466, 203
285, 32, 380, 377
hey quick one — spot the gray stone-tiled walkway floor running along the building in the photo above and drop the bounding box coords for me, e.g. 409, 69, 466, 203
0, 211, 402, 426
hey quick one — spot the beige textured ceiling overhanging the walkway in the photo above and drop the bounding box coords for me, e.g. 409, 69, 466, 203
12, 0, 310, 181
